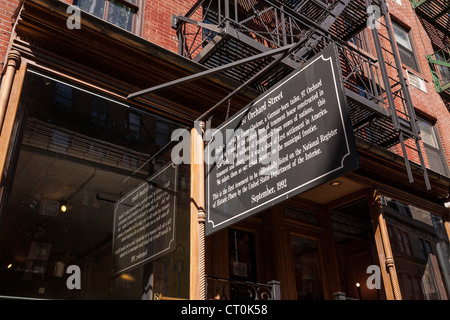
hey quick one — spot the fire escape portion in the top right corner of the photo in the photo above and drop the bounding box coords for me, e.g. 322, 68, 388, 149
411, 0, 450, 102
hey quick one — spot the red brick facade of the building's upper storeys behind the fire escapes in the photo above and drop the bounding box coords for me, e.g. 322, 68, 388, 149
0, 0, 450, 175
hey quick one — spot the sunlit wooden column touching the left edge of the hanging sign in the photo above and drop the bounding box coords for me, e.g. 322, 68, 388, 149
190, 122, 206, 300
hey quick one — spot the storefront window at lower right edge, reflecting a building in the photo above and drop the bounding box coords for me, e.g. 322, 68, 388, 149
382, 196, 450, 300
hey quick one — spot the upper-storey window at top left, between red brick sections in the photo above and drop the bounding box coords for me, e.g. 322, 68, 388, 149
73, 0, 140, 33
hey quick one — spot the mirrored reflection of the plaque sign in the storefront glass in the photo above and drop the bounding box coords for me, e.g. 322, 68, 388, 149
112, 164, 177, 273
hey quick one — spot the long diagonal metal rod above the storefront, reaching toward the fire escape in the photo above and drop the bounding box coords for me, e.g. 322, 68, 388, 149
127, 44, 295, 99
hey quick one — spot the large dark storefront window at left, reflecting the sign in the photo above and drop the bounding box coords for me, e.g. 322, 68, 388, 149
0, 71, 190, 299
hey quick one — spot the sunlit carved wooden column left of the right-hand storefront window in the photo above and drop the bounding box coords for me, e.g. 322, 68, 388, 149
369, 190, 402, 300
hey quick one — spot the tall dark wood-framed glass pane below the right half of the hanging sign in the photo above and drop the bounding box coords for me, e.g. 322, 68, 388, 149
291, 236, 323, 300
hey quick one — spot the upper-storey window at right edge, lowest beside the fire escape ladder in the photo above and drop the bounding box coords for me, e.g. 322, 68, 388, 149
419, 120, 448, 176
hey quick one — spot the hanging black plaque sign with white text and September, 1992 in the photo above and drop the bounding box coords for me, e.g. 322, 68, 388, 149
205, 45, 359, 234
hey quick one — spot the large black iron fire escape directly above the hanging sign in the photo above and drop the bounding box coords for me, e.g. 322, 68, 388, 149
166, 0, 432, 189
